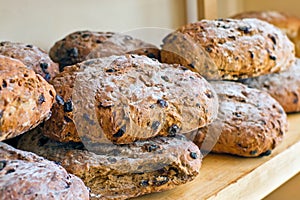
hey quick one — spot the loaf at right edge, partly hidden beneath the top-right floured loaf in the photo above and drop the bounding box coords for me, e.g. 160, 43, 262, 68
240, 59, 300, 113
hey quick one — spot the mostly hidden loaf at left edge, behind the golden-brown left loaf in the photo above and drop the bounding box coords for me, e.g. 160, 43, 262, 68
0, 42, 59, 81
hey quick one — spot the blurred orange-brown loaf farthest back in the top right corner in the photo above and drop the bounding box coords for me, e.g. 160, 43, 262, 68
232, 11, 300, 57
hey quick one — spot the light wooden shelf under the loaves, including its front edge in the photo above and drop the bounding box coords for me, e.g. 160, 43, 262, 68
135, 114, 300, 200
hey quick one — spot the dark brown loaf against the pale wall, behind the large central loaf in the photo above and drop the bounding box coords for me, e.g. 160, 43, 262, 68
49, 31, 160, 71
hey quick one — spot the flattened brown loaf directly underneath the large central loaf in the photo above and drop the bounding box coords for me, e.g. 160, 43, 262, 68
18, 129, 202, 199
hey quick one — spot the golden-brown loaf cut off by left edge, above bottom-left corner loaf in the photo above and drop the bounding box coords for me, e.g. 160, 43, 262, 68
0, 56, 56, 141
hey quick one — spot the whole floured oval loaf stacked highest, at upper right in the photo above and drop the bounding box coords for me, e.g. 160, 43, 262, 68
161, 19, 295, 80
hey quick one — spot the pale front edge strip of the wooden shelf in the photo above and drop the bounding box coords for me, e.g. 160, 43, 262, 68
208, 142, 300, 200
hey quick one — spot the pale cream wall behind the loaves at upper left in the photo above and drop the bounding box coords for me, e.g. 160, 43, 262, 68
0, 0, 186, 49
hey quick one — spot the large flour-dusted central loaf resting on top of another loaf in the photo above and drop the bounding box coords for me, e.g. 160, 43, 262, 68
43, 55, 218, 144
